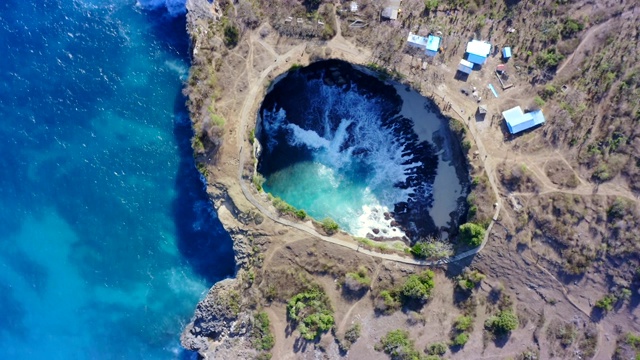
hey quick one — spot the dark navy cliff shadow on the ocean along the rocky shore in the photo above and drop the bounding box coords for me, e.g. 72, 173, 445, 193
172, 93, 236, 285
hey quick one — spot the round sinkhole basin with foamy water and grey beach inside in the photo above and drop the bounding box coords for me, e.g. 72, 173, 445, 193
256, 60, 469, 242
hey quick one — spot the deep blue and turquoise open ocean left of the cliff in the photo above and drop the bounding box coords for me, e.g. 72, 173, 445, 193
0, 0, 235, 359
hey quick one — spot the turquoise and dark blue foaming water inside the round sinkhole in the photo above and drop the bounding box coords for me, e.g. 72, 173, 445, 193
259, 63, 437, 238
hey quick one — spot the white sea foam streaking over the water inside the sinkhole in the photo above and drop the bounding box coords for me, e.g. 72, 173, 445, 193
262, 80, 428, 237
